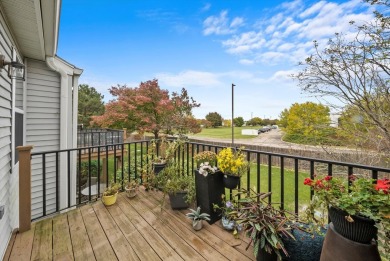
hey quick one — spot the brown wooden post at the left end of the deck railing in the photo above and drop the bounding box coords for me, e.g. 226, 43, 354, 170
16, 146, 33, 232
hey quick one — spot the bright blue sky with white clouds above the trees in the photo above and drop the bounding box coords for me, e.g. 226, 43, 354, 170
58, 0, 373, 120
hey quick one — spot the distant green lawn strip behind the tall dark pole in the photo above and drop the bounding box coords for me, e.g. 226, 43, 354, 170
192, 126, 260, 139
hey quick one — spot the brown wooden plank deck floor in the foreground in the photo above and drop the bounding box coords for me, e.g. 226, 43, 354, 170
5, 189, 255, 261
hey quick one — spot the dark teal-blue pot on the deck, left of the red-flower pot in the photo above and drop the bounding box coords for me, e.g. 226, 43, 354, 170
282, 223, 326, 261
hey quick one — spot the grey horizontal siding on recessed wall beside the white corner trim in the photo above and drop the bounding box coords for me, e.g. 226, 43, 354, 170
26, 59, 60, 218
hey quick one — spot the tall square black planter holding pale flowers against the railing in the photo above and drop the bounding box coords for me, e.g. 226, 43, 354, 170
195, 170, 225, 224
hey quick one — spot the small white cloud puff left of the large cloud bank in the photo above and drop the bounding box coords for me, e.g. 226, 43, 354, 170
203, 10, 244, 35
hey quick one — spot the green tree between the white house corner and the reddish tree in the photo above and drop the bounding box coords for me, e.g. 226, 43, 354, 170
78, 84, 104, 127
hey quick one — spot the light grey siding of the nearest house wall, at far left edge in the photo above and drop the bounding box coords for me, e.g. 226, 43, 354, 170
0, 17, 12, 259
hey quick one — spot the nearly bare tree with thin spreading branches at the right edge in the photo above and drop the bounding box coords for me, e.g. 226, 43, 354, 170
293, 0, 390, 150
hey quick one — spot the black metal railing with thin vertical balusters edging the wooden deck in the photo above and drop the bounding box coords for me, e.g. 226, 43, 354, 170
31, 140, 390, 220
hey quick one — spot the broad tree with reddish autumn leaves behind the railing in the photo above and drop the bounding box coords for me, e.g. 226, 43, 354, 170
93, 79, 200, 138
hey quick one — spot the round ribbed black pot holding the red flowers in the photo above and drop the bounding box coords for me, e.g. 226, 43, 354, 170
329, 207, 378, 244
